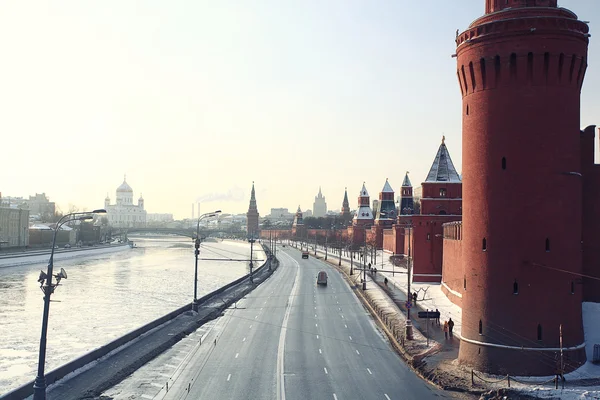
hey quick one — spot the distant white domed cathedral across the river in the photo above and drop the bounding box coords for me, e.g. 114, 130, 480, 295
104, 178, 147, 228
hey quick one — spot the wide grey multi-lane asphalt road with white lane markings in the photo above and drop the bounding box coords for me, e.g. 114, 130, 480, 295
150, 247, 452, 400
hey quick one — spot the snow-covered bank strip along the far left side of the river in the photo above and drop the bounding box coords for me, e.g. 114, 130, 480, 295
0, 243, 130, 268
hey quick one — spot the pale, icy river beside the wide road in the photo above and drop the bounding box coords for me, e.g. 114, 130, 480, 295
0, 236, 264, 394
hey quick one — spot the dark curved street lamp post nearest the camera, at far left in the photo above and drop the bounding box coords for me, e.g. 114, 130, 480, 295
33, 209, 106, 400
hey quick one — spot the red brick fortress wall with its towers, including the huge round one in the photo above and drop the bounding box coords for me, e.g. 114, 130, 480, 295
254, 0, 600, 376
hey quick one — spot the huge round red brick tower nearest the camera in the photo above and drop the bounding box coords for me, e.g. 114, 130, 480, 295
456, 0, 589, 375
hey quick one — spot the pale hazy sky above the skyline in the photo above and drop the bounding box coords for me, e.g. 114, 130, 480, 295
0, 0, 600, 218
